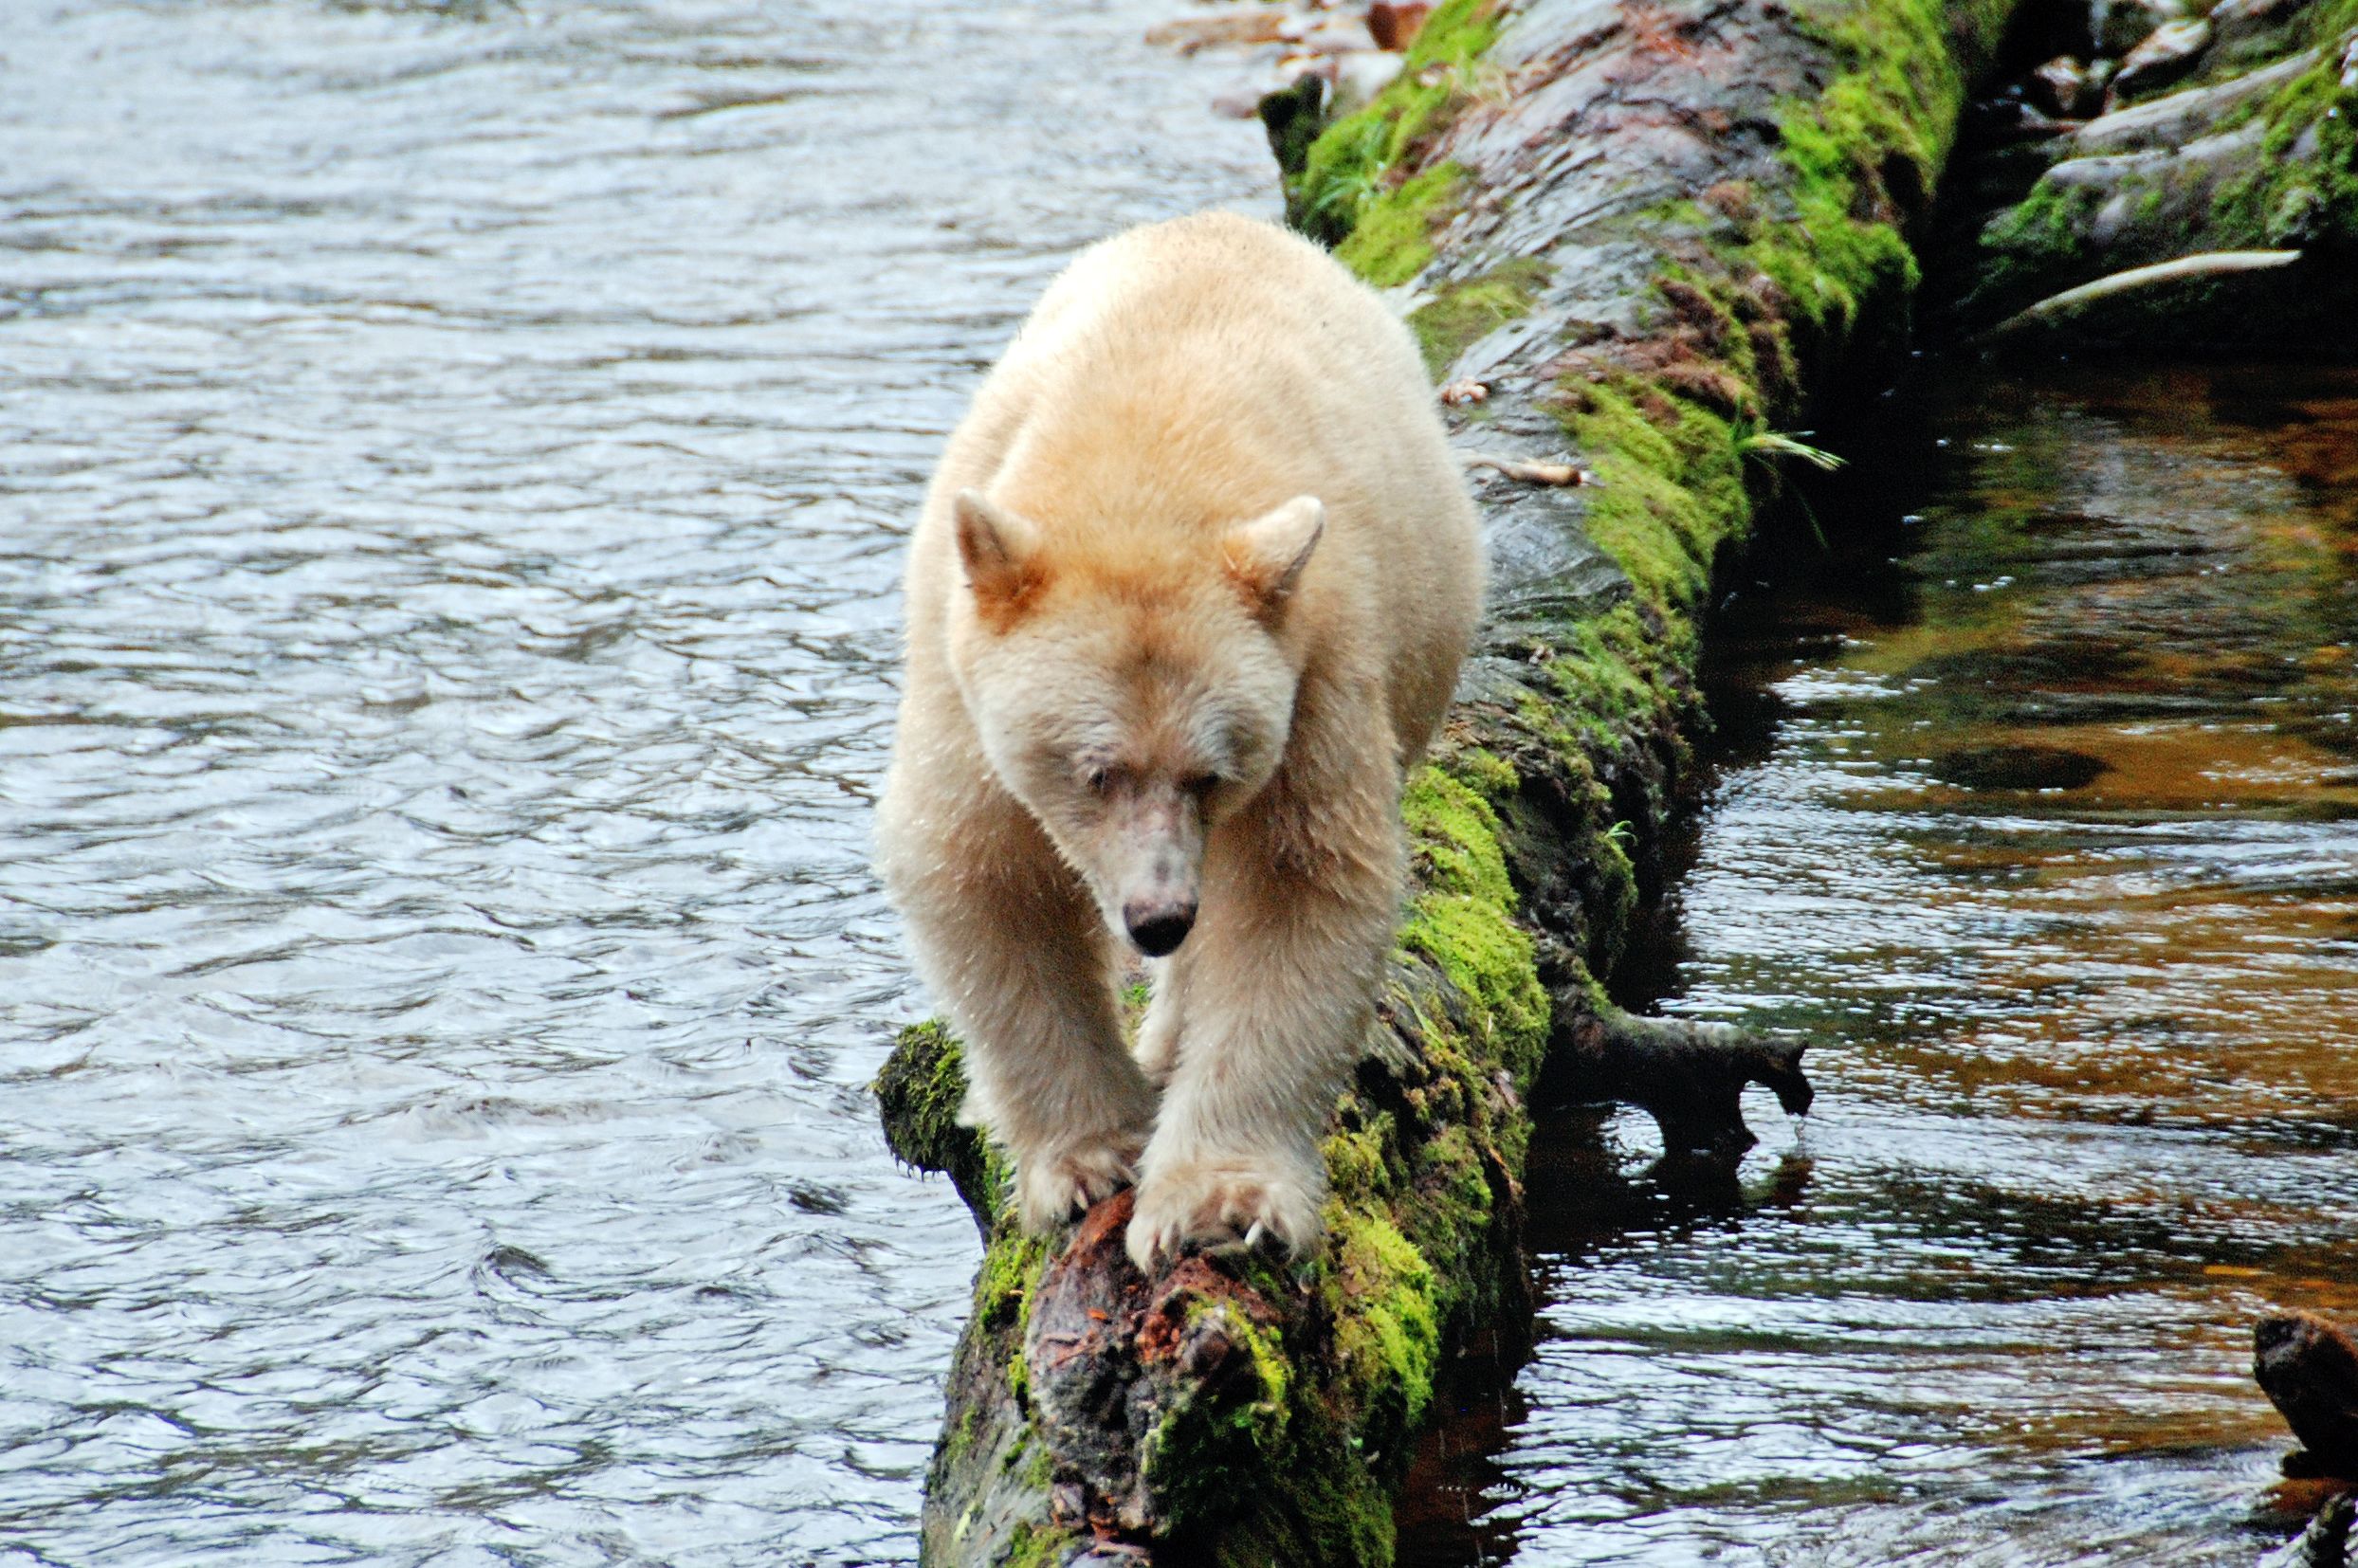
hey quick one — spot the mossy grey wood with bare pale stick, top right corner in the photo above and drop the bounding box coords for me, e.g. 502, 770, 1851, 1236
1960, 0, 2358, 341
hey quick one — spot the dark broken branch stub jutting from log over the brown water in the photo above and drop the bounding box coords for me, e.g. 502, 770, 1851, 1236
1551, 1007, 1816, 1160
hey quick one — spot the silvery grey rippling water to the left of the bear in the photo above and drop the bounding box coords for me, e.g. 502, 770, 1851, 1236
0, 0, 1273, 1566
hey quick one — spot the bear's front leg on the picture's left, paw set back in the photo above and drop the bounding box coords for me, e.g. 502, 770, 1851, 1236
887, 813, 1156, 1231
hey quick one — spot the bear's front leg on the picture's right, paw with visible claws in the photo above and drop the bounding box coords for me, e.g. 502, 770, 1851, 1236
1129, 830, 1398, 1271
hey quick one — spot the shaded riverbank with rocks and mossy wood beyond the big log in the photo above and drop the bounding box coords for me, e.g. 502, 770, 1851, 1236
1946, 0, 2358, 341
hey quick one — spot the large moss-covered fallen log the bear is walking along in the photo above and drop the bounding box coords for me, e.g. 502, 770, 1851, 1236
877, 0, 2009, 1568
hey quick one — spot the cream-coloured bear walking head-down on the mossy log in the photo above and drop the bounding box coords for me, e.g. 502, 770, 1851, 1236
877, 212, 1481, 1271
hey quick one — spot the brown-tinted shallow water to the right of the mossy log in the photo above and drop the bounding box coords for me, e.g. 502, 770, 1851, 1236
1410, 366, 2358, 1566
